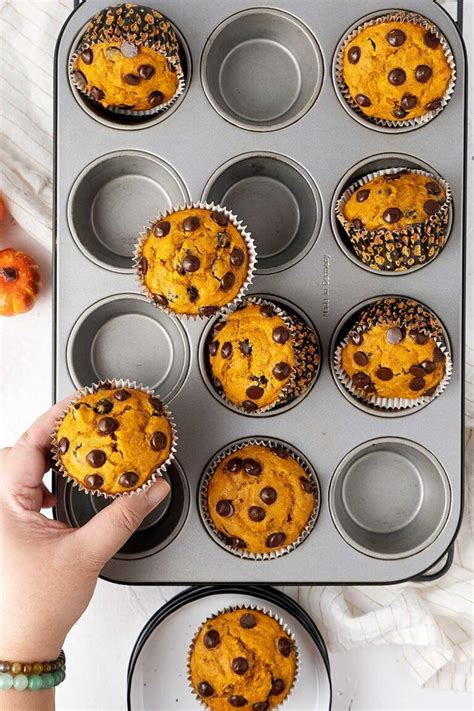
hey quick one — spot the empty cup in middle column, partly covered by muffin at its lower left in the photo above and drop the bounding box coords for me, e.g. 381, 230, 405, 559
203, 153, 322, 273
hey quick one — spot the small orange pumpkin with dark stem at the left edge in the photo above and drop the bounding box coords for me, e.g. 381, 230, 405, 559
0, 249, 40, 316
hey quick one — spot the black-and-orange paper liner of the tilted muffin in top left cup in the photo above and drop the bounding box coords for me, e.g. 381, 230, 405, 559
68, 3, 186, 117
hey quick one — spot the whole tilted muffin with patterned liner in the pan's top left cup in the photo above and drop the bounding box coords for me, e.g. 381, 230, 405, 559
71, 3, 184, 113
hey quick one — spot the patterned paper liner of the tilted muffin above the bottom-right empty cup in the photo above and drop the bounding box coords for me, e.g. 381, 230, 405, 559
333, 298, 453, 410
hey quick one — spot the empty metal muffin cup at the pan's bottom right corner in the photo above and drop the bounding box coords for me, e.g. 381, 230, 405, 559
329, 437, 451, 560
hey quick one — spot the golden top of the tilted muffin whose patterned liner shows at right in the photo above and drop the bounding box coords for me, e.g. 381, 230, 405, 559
209, 303, 295, 412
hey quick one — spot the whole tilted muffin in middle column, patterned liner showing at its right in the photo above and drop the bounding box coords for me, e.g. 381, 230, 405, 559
207, 297, 319, 413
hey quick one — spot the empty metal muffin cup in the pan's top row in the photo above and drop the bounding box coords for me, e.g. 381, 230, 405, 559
201, 8, 323, 131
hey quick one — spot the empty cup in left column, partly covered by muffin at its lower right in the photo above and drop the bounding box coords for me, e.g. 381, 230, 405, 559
67, 151, 189, 273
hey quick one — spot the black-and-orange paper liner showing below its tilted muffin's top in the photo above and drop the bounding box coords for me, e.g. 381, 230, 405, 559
335, 168, 452, 273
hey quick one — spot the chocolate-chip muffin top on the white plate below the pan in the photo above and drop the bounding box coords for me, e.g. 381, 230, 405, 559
189, 608, 297, 711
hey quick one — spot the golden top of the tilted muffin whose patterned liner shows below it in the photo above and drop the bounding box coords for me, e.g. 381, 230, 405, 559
342, 169, 446, 230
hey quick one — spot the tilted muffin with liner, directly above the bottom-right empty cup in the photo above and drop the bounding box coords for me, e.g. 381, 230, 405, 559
336, 298, 449, 403
